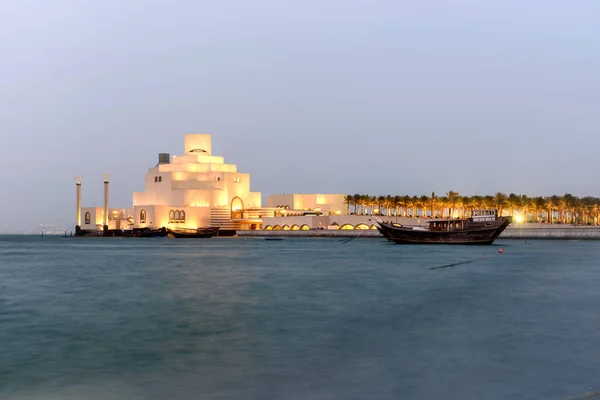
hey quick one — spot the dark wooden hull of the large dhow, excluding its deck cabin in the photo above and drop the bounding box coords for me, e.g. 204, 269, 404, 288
379, 217, 510, 245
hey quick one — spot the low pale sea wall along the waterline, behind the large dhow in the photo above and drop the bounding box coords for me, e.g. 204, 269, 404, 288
237, 224, 600, 240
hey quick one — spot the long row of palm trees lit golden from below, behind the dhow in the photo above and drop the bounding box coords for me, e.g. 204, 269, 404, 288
344, 190, 600, 225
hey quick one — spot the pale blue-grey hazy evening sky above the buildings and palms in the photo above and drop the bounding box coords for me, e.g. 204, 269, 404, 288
0, 0, 600, 232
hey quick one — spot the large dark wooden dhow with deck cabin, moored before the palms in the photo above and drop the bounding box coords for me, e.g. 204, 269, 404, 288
377, 210, 512, 244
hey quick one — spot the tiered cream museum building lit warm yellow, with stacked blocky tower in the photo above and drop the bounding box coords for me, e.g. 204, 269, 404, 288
133, 134, 261, 229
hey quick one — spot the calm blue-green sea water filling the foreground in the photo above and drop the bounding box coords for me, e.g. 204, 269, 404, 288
0, 236, 600, 400
